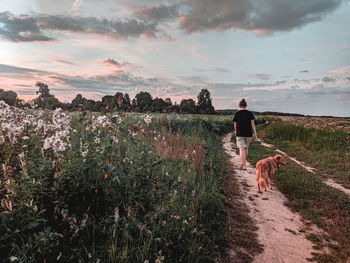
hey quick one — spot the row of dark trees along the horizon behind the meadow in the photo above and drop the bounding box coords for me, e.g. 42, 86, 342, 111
0, 81, 215, 114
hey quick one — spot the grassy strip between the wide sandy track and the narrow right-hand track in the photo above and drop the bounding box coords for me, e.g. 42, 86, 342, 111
248, 142, 350, 262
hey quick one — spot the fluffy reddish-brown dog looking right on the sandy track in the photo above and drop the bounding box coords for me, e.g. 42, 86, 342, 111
255, 154, 286, 191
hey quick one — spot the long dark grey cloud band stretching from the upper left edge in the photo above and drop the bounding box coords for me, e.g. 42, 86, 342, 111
0, 12, 159, 42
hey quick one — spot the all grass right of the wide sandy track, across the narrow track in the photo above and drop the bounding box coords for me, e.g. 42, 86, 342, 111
248, 117, 350, 262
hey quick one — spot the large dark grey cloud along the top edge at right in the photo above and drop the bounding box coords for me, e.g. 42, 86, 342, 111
180, 0, 343, 36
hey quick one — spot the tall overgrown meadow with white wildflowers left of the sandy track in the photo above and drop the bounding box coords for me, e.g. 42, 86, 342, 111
0, 101, 232, 263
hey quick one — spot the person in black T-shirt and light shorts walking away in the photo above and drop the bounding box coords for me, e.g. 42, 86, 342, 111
233, 99, 258, 170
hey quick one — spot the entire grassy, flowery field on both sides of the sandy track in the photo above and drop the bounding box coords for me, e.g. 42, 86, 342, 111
0, 101, 350, 263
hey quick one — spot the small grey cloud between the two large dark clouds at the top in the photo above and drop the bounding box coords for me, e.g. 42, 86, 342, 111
135, 5, 178, 21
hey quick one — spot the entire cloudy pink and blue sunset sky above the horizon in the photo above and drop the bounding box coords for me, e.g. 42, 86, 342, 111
0, 0, 350, 117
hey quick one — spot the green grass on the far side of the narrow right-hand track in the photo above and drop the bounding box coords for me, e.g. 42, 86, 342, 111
259, 121, 350, 189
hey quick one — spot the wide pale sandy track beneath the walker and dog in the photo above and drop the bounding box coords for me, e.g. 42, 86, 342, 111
223, 133, 313, 263
